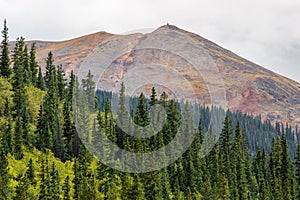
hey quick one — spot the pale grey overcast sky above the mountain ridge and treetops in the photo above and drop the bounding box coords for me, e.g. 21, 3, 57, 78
0, 0, 300, 82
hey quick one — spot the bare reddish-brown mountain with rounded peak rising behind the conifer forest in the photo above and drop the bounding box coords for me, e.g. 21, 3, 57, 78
17, 25, 300, 126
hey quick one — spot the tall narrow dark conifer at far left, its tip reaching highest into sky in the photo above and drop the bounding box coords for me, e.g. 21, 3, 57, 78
0, 19, 11, 78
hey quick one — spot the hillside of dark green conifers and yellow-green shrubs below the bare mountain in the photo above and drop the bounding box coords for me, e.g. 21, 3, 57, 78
0, 19, 300, 200
